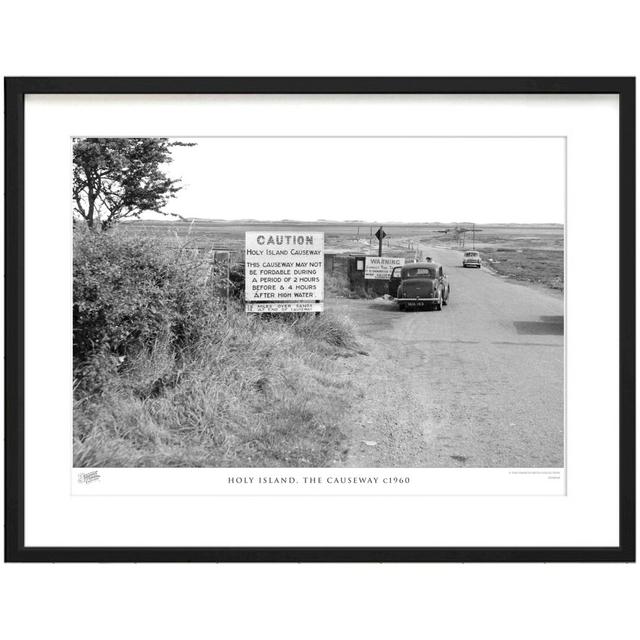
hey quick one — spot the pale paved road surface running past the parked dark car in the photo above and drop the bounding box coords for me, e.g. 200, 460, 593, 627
328, 249, 564, 467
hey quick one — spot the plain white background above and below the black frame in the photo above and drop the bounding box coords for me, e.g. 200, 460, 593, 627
0, 0, 640, 640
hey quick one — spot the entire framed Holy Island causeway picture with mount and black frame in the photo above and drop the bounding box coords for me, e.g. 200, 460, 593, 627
5, 77, 635, 562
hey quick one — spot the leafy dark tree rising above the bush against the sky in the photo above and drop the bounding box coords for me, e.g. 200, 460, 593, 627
73, 138, 193, 230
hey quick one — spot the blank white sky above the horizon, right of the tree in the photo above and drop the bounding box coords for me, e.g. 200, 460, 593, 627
155, 137, 565, 224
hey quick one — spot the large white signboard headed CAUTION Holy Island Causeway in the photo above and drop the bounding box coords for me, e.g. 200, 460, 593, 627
245, 230, 324, 313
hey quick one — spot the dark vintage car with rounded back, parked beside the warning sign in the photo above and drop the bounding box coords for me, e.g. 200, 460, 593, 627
389, 262, 451, 311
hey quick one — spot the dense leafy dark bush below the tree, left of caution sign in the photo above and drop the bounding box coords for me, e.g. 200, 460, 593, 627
73, 228, 220, 388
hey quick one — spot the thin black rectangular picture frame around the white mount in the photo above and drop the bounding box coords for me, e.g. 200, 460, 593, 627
4, 77, 636, 562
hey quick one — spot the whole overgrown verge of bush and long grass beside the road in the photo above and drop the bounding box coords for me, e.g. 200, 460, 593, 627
74, 228, 358, 467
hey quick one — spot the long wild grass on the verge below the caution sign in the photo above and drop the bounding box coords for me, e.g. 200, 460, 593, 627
74, 298, 357, 467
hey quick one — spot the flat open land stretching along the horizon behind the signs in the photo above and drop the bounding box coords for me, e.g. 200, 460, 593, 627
120, 220, 564, 290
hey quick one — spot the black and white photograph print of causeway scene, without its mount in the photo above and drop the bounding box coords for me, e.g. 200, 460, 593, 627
69, 135, 564, 469
